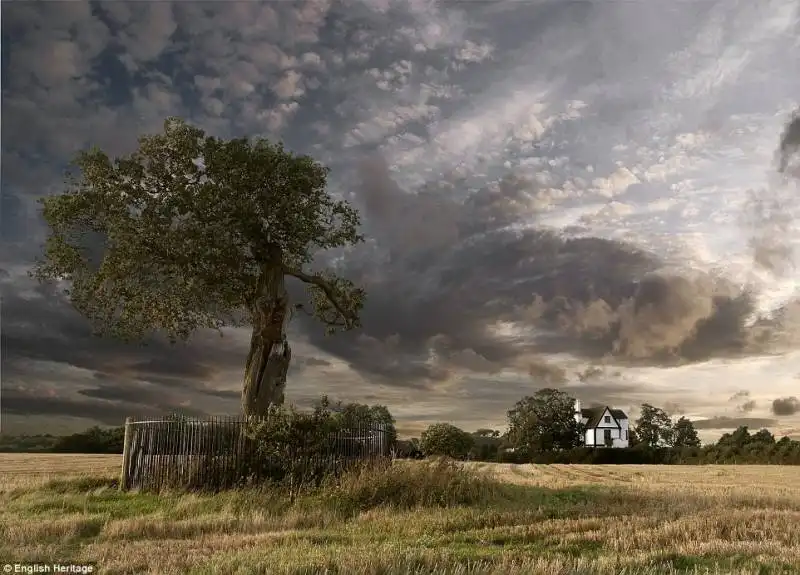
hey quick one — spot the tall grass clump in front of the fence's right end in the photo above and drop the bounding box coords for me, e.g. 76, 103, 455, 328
320, 458, 505, 511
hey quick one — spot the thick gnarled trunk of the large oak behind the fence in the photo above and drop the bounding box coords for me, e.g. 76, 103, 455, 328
242, 265, 292, 417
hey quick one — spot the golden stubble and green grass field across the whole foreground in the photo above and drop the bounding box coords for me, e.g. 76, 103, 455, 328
0, 454, 800, 575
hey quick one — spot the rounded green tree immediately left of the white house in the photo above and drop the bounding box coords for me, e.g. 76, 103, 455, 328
508, 388, 582, 452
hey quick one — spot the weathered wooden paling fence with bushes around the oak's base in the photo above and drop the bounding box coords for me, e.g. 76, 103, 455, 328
120, 417, 394, 490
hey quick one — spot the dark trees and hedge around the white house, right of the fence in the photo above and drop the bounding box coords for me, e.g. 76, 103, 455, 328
398, 389, 800, 465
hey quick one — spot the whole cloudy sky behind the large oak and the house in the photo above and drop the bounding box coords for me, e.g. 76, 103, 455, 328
0, 0, 800, 439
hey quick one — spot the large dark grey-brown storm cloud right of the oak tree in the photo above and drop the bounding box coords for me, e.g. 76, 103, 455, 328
298, 132, 795, 388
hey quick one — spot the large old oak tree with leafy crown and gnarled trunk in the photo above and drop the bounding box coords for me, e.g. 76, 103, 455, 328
33, 118, 364, 415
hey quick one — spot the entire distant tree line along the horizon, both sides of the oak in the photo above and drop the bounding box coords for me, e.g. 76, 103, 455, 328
0, 389, 800, 465
